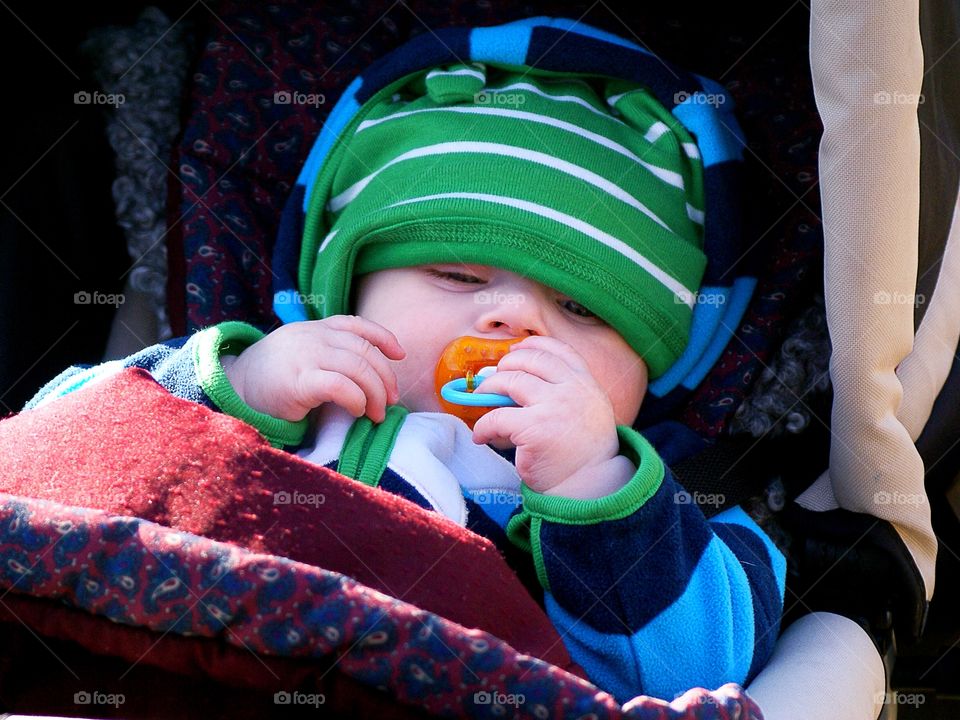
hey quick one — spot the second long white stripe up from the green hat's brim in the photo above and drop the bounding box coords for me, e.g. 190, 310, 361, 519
327, 140, 676, 235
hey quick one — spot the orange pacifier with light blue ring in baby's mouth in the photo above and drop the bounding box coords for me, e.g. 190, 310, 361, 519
434, 336, 523, 430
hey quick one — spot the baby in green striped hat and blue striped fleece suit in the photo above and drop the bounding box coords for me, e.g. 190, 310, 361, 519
28, 63, 785, 702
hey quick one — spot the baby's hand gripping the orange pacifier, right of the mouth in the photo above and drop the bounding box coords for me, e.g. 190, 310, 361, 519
473, 336, 630, 497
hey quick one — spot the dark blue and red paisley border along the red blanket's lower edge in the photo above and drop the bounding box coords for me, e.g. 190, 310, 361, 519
0, 494, 762, 720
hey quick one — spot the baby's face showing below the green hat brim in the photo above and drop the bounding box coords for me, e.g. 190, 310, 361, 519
355, 263, 647, 425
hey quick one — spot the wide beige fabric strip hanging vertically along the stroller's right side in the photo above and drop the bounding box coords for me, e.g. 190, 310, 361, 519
798, 0, 937, 598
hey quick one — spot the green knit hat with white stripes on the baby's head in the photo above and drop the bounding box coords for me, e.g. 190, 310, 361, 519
300, 63, 706, 379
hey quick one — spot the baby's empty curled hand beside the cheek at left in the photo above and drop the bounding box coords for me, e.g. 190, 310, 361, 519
222, 315, 406, 422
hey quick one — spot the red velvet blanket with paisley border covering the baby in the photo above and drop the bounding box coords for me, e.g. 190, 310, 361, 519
0, 369, 760, 718
